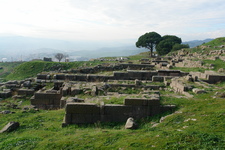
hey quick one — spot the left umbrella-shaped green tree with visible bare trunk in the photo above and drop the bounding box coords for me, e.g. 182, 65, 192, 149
136, 32, 162, 57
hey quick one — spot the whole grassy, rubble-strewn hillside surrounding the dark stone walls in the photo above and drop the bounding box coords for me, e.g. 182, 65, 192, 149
0, 38, 225, 150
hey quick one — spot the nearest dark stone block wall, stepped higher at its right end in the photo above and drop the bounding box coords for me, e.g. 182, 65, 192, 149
63, 95, 175, 125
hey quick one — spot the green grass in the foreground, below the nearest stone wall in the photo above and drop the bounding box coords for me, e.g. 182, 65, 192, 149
0, 40, 225, 150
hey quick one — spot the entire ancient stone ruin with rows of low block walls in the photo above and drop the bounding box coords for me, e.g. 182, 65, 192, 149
0, 54, 225, 126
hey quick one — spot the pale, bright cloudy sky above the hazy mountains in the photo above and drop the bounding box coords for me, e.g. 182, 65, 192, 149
0, 0, 225, 41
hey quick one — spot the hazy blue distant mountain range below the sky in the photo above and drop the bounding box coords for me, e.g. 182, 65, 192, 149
0, 36, 213, 61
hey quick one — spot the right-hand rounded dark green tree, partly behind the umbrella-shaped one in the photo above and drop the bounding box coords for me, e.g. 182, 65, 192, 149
156, 35, 182, 55
